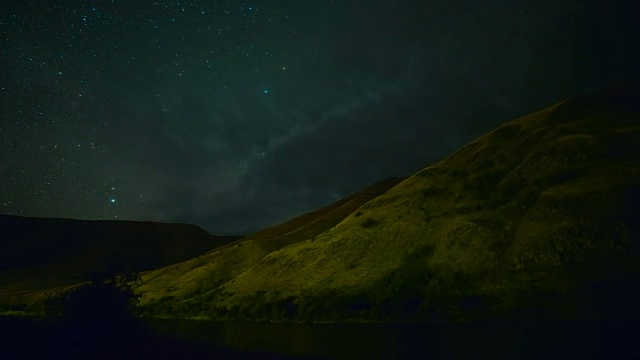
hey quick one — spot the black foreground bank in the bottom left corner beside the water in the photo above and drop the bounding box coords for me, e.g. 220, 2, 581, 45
0, 317, 282, 360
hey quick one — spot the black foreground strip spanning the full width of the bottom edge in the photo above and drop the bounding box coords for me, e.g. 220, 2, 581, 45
0, 318, 640, 359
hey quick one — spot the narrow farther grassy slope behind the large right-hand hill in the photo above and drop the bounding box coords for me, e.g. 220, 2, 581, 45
136, 178, 404, 317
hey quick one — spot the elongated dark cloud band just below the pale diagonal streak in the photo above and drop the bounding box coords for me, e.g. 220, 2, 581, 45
194, 86, 460, 232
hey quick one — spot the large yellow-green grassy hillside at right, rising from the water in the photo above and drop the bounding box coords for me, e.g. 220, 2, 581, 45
140, 86, 640, 321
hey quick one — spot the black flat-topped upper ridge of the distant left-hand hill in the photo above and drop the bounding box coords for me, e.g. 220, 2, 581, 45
0, 215, 239, 271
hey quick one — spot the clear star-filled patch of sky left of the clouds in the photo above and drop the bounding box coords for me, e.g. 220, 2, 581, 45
1, 1, 304, 222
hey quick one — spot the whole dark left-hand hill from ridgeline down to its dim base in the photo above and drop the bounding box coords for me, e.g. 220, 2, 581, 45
0, 215, 238, 309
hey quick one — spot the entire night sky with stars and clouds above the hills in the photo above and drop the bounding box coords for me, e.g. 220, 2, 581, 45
0, 0, 640, 234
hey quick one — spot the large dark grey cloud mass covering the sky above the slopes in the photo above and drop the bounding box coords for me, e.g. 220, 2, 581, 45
99, 1, 638, 233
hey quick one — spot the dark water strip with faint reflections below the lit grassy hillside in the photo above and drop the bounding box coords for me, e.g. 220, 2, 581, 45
153, 320, 640, 359
